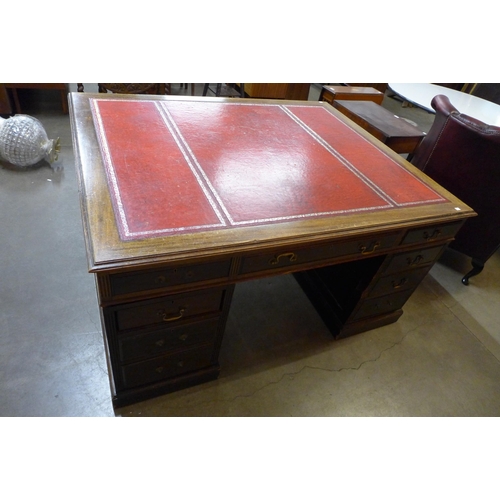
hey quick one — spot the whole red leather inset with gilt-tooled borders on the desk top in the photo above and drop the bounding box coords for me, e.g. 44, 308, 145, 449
90, 98, 447, 240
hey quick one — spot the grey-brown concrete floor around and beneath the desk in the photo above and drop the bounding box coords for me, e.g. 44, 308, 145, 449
0, 84, 500, 417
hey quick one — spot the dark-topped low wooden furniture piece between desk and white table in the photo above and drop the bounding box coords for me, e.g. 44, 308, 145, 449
332, 100, 425, 155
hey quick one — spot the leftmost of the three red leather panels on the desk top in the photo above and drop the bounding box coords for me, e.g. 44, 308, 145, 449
90, 101, 223, 239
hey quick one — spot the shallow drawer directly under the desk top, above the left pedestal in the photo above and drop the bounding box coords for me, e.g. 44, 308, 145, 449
109, 260, 231, 295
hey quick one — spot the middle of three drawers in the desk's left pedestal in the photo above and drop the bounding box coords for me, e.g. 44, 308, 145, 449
118, 317, 219, 363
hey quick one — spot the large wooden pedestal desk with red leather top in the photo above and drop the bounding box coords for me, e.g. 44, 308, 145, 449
69, 93, 474, 406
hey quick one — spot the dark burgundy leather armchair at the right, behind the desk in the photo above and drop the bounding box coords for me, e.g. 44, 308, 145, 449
411, 95, 500, 285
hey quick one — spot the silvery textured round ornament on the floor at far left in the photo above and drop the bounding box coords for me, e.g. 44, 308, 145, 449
0, 115, 60, 170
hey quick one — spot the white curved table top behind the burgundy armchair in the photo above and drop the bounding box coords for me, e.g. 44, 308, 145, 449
389, 83, 500, 127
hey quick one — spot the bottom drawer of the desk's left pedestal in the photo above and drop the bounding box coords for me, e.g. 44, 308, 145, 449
121, 346, 213, 389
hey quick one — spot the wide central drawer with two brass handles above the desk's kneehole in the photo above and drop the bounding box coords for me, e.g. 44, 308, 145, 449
240, 233, 400, 274
